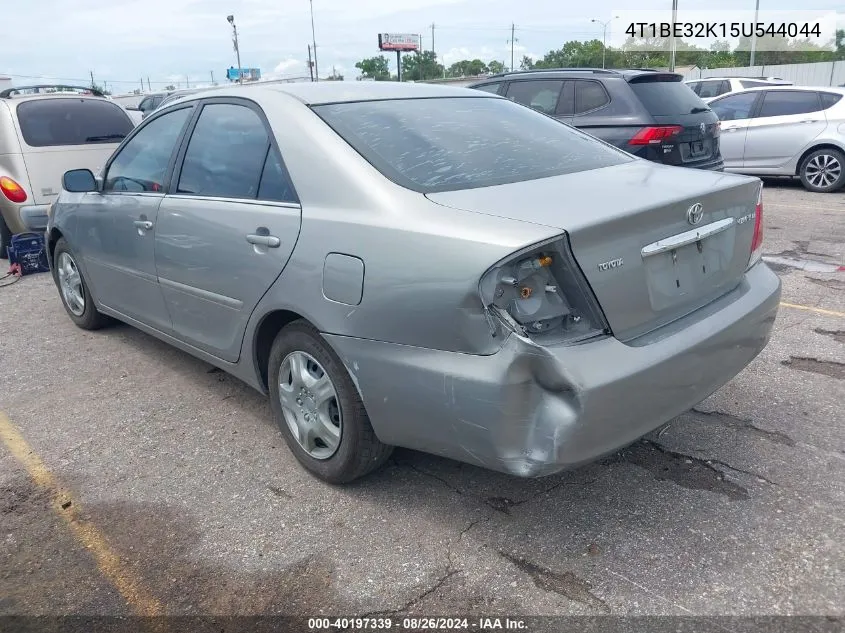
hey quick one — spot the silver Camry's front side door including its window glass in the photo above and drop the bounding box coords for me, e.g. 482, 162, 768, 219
76, 106, 193, 332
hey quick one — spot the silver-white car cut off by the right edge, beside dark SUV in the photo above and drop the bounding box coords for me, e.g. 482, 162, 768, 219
710, 86, 845, 193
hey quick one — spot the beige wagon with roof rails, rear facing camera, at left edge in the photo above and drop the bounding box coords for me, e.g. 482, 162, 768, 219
0, 85, 133, 258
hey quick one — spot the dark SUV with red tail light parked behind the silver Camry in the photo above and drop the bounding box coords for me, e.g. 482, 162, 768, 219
470, 68, 723, 169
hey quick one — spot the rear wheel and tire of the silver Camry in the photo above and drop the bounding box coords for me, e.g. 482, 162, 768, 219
268, 320, 393, 484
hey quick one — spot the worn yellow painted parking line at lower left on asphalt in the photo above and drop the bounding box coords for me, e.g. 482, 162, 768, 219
0, 412, 164, 616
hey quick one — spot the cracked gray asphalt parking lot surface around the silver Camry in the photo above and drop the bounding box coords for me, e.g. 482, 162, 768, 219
0, 182, 845, 616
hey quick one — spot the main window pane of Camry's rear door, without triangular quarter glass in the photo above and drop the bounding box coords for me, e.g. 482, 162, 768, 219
176, 103, 270, 198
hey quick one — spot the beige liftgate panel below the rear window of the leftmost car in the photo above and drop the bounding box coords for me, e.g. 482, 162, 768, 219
23, 143, 118, 204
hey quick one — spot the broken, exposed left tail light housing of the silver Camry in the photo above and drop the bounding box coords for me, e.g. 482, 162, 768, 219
478, 234, 610, 343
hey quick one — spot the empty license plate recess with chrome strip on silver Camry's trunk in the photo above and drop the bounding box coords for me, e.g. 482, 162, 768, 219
643, 218, 735, 311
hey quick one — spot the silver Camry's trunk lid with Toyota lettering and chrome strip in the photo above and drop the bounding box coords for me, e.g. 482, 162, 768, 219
427, 160, 760, 341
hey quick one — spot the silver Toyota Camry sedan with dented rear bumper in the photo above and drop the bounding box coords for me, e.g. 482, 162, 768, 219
47, 82, 780, 483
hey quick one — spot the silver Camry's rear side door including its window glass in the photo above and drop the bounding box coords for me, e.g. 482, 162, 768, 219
155, 98, 301, 362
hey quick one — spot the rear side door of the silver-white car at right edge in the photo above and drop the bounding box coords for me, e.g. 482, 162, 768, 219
744, 90, 827, 170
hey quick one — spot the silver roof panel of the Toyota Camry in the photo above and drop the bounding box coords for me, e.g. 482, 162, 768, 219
163, 81, 488, 105
